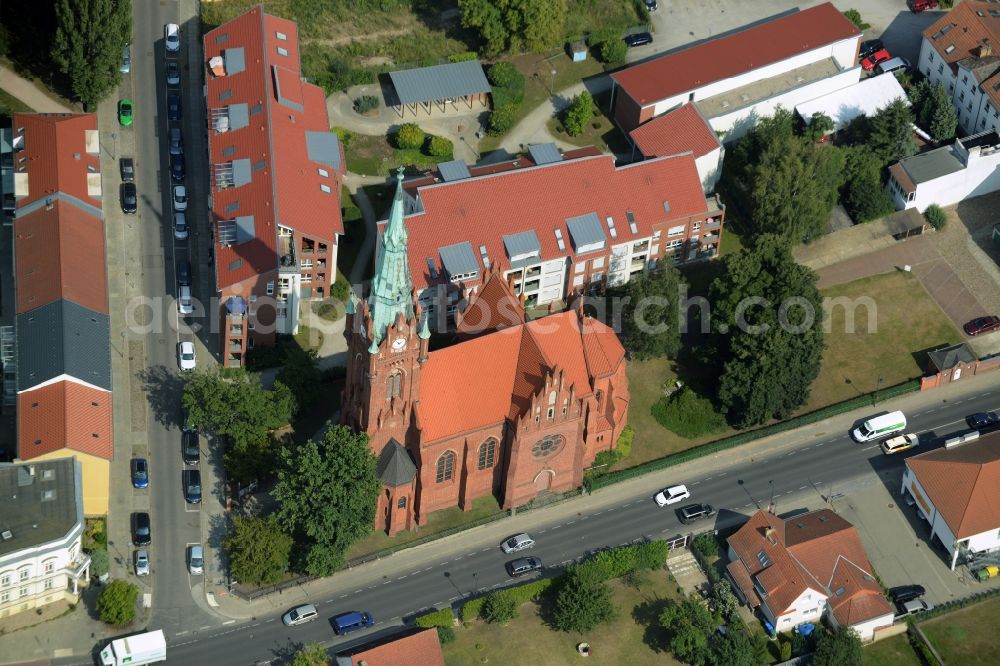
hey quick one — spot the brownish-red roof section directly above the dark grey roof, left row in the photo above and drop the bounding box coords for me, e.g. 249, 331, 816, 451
14, 200, 108, 314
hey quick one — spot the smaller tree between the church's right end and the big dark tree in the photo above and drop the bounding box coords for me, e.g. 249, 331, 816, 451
611, 257, 686, 361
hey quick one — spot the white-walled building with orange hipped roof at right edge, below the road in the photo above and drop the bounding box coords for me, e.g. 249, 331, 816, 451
901, 431, 1000, 570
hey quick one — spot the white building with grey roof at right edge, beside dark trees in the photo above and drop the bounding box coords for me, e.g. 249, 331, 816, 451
889, 130, 1000, 213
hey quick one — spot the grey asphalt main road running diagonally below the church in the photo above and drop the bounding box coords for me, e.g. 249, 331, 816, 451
68, 391, 1000, 664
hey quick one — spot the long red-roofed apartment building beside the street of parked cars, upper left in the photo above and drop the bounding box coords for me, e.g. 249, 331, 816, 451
204, 6, 346, 366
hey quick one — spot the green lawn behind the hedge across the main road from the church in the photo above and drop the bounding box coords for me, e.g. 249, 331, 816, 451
442, 570, 680, 666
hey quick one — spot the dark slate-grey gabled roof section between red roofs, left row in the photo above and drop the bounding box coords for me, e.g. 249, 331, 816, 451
16, 299, 111, 391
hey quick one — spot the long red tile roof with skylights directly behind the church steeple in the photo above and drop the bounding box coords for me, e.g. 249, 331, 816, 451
396, 155, 708, 292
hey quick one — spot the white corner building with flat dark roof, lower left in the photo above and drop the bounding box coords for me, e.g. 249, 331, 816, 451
0, 458, 90, 617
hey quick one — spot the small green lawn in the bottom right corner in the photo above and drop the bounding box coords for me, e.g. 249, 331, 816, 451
920, 598, 1000, 666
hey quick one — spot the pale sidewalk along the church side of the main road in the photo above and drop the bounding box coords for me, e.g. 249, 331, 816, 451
201, 373, 997, 619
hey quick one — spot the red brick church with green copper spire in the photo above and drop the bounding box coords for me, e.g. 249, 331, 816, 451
341, 174, 629, 534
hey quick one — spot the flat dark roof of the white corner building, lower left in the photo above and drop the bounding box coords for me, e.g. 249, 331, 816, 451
0, 457, 83, 557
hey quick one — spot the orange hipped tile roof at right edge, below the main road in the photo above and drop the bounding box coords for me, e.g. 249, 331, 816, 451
906, 432, 1000, 539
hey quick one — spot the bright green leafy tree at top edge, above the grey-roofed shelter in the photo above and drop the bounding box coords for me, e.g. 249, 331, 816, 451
458, 0, 566, 57
